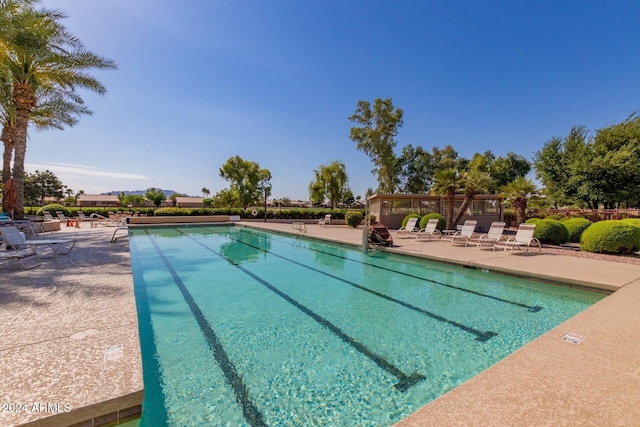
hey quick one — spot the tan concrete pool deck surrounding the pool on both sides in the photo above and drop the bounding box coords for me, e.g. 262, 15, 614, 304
0, 222, 640, 427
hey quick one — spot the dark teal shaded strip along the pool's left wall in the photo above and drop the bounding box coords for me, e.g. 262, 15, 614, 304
129, 239, 169, 424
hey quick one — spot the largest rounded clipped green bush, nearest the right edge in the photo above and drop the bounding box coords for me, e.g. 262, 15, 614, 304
580, 220, 640, 254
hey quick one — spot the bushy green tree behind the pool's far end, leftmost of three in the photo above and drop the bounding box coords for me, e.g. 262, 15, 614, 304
220, 156, 271, 209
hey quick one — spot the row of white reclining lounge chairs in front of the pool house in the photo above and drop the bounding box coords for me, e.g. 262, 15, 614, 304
396, 218, 541, 252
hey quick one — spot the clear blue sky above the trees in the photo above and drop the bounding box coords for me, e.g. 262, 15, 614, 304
26, 0, 640, 200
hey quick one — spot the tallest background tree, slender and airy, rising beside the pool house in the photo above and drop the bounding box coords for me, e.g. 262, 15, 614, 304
349, 98, 403, 193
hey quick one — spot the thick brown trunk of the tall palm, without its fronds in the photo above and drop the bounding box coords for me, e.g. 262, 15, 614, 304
13, 82, 36, 219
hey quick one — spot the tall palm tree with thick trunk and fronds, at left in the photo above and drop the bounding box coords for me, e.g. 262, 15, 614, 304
0, 7, 116, 218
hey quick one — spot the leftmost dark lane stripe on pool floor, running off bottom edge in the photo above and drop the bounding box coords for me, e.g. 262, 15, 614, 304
145, 230, 267, 427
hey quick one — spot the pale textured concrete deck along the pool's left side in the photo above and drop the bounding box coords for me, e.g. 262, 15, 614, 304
0, 224, 143, 427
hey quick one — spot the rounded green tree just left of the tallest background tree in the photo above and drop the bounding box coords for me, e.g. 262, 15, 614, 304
309, 160, 353, 209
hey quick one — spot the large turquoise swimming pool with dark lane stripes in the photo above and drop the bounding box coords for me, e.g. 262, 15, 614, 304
130, 226, 603, 426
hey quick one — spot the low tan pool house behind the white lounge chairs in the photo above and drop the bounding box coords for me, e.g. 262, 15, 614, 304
369, 194, 504, 231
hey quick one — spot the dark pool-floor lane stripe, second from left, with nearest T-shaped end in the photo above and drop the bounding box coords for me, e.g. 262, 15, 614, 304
176, 230, 426, 392
